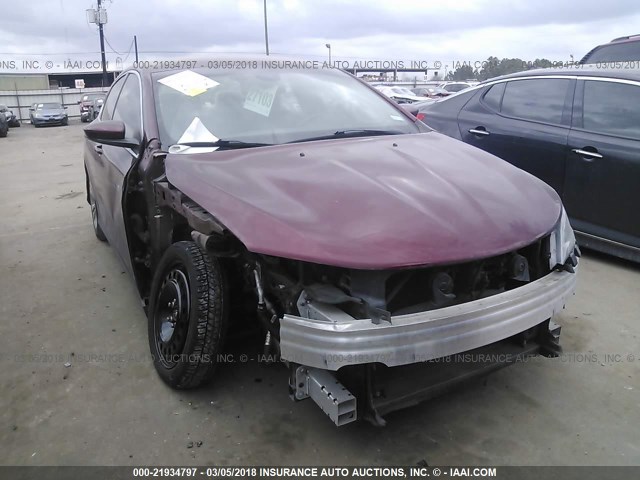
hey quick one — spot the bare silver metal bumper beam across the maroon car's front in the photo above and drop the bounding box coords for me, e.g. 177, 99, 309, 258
280, 271, 576, 370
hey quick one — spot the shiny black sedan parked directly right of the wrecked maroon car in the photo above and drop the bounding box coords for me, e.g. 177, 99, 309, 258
420, 65, 640, 261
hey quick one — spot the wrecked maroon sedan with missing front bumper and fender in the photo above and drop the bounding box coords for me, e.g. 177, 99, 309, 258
84, 64, 579, 425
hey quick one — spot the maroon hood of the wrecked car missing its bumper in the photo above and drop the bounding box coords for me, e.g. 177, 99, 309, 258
165, 132, 561, 269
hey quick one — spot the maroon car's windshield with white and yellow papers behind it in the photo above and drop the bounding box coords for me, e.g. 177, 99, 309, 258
153, 69, 419, 147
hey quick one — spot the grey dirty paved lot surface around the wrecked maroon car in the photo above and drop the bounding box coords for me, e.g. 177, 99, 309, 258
0, 120, 640, 465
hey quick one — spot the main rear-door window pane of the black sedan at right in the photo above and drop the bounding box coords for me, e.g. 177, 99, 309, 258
500, 78, 571, 123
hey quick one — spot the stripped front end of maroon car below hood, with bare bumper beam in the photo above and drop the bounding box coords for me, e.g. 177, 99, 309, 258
270, 212, 580, 425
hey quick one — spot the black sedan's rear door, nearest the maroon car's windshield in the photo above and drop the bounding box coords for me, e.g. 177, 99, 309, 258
458, 77, 575, 195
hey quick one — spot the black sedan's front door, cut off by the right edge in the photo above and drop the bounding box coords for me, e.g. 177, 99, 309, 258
564, 77, 640, 247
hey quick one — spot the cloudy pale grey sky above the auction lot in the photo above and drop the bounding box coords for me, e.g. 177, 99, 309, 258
0, 0, 640, 73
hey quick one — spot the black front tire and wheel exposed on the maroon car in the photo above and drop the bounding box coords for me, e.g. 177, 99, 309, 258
148, 242, 228, 389
